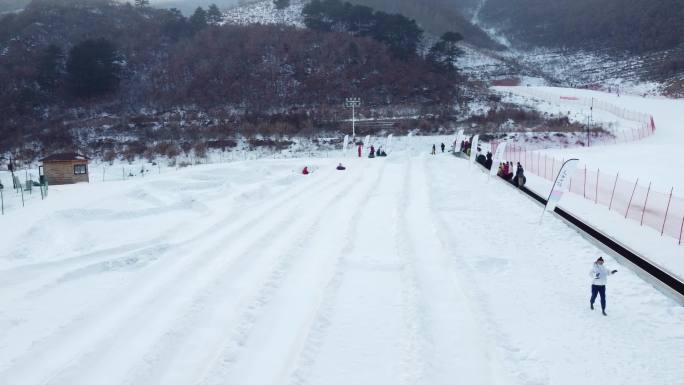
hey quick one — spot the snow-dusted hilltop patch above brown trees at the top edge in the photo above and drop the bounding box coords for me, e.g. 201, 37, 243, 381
223, 0, 308, 28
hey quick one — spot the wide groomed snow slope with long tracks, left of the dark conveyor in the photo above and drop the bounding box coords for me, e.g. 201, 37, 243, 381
0, 151, 684, 385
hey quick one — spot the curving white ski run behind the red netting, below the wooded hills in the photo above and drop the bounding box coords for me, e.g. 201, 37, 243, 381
495, 87, 684, 190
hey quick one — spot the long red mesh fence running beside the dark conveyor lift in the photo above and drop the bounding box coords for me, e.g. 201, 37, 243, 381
500, 143, 684, 245
